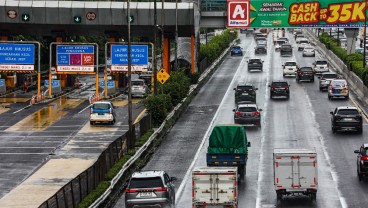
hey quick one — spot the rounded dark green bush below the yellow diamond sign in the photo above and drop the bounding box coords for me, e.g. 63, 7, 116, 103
143, 94, 173, 126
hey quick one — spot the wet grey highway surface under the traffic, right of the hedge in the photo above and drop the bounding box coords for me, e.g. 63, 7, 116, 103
115, 30, 368, 208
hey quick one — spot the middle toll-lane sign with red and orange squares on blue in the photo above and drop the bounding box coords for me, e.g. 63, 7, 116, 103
56, 45, 95, 72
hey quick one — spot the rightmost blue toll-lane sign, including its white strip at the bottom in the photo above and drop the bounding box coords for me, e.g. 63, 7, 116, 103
111, 44, 148, 72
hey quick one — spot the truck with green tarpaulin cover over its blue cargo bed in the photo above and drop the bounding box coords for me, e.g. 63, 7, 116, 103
207, 125, 250, 177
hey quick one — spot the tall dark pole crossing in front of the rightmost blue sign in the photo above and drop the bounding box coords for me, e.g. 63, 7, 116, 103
127, 0, 134, 148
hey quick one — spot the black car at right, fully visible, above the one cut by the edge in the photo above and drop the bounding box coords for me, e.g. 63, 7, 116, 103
330, 107, 363, 134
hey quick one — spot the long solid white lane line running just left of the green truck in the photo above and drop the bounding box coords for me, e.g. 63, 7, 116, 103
175, 43, 250, 202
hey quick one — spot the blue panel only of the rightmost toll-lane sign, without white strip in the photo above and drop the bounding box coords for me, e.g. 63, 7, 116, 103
111, 45, 148, 65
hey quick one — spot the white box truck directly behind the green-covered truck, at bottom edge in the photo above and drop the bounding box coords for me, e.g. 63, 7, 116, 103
192, 167, 238, 208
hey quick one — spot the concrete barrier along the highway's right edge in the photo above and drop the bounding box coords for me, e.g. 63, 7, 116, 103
306, 29, 368, 106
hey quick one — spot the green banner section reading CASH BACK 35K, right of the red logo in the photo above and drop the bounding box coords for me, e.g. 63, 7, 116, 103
250, 0, 366, 28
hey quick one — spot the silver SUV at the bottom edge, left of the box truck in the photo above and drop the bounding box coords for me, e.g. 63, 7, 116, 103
125, 171, 176, 208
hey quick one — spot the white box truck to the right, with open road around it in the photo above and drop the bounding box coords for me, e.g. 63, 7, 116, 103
273, 149, 318, 203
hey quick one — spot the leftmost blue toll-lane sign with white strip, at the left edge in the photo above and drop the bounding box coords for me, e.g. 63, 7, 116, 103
0, 43, 35, 71
